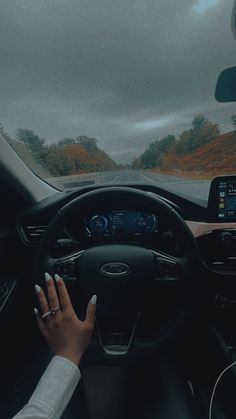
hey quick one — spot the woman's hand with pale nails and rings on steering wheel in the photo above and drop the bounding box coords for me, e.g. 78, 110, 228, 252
34, 273, 97, 365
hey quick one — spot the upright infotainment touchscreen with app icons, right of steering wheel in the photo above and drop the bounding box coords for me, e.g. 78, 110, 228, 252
208, 176, 236, 222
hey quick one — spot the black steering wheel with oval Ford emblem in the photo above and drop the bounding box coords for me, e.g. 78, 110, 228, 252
34, 187, 202, 359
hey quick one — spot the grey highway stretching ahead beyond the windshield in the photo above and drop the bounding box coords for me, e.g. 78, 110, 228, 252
48, 170, 210, 199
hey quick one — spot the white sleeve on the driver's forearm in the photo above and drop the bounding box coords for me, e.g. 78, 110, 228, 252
13, 356, 81, 419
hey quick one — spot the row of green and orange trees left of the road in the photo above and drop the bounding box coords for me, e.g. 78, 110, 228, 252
10, 126, 117, 176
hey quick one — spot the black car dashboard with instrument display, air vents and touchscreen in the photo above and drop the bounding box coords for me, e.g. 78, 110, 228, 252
11, 176, 236, 348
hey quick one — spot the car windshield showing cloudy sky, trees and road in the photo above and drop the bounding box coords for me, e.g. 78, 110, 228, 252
0, 0, 236, 198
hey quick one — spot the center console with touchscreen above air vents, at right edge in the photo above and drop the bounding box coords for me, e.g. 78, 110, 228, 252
201, 176, 236, 348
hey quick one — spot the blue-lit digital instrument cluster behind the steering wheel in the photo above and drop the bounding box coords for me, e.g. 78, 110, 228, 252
84, 210, 158, 236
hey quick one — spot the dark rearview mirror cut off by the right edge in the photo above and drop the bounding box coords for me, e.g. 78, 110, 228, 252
215, 67, 236, 102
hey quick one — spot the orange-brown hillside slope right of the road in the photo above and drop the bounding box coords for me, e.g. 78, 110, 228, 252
161, 131, 236, 176
